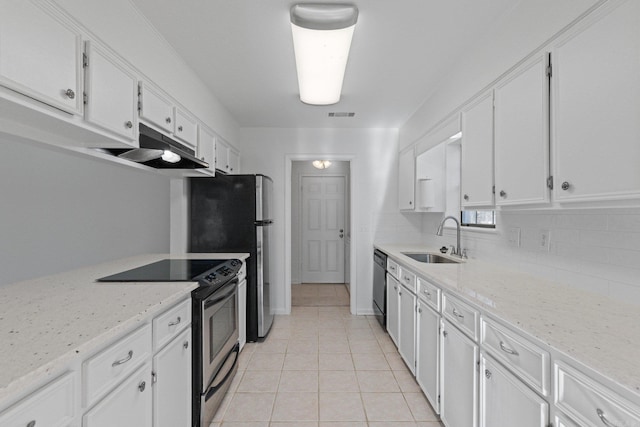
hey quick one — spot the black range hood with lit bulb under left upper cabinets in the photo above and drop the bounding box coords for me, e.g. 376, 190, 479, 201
102, 123, 209, 169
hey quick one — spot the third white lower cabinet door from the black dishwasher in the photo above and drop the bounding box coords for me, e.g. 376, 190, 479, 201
416, 300, 440, 414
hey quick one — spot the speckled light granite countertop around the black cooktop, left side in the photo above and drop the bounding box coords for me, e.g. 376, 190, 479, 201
0, 253, 249, 404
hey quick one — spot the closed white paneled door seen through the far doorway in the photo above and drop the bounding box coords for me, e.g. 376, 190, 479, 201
301, 176, 345, 283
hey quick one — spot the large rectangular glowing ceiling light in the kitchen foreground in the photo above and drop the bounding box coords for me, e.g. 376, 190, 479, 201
291, 3, 358, 105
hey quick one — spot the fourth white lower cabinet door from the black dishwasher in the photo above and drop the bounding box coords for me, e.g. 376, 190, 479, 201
440, 320, 478, 427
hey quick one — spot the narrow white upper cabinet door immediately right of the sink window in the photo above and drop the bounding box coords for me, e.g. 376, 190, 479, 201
461, 92, 493, 207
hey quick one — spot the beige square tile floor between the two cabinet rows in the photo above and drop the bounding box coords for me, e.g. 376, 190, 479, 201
211, 285, 441, 427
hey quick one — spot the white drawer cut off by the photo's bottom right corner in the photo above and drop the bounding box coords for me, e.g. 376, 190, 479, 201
555, 362, 640, 427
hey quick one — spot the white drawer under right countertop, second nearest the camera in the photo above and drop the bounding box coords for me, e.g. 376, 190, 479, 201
480, 318, 549, 396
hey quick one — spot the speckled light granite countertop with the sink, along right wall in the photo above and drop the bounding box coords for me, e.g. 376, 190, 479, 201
374, 244, 640, 393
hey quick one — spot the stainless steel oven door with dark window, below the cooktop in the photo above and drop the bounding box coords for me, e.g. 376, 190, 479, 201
200, 278, 238, 393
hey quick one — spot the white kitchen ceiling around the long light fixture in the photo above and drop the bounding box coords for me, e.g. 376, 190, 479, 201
131, 0, 520, 128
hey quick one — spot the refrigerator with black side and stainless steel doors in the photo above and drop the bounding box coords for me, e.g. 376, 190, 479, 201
189, 175, 273, 341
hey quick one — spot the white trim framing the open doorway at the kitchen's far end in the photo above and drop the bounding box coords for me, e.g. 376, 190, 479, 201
284, 154, 359, 314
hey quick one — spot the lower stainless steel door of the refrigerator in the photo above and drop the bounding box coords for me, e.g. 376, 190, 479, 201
256, 222, 273, 338
